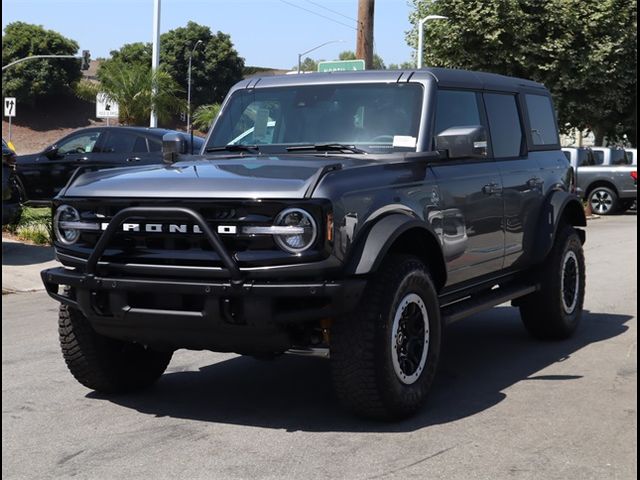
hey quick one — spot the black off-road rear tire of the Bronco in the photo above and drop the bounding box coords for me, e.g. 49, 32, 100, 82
519, 225, 585, 340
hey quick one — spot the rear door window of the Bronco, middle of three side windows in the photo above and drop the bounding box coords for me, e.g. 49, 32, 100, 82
484, 93, 524, 158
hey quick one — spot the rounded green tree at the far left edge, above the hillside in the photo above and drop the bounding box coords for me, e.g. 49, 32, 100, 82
2, 22, 82, 105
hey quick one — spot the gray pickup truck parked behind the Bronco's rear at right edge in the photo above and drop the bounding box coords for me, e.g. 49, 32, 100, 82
562, 147, 638, 215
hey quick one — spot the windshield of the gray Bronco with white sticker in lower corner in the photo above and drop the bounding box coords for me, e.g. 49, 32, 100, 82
206, 83, 422, 153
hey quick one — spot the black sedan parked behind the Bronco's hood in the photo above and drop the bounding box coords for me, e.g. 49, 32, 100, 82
16, 127, 204, 205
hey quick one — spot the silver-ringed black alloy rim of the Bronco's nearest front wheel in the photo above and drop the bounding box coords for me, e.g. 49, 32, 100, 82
391, 293, 429, 385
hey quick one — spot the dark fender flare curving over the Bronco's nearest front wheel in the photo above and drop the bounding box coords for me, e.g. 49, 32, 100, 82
346, 213, 446, 282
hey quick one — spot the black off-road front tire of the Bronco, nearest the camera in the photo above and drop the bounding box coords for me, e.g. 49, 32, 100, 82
330, 255, 442, 419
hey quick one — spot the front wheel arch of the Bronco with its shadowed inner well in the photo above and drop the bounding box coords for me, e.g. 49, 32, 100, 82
347, 213, 447, 291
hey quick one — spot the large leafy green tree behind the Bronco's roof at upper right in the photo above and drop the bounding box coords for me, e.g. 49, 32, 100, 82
407, 0, 637, 145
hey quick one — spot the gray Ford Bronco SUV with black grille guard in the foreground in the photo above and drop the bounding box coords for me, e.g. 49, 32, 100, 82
42, 68, 586, 418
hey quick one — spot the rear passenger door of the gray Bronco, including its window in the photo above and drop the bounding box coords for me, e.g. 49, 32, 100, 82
483, 92, 544, 268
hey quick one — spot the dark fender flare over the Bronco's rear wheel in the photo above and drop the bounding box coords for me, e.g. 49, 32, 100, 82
534, 190, 587, 263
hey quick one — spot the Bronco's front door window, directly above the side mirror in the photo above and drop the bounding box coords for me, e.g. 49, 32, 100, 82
434, 90, 482, 135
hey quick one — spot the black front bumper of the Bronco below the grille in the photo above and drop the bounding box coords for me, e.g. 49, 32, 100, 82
41, 267, 365, 353
